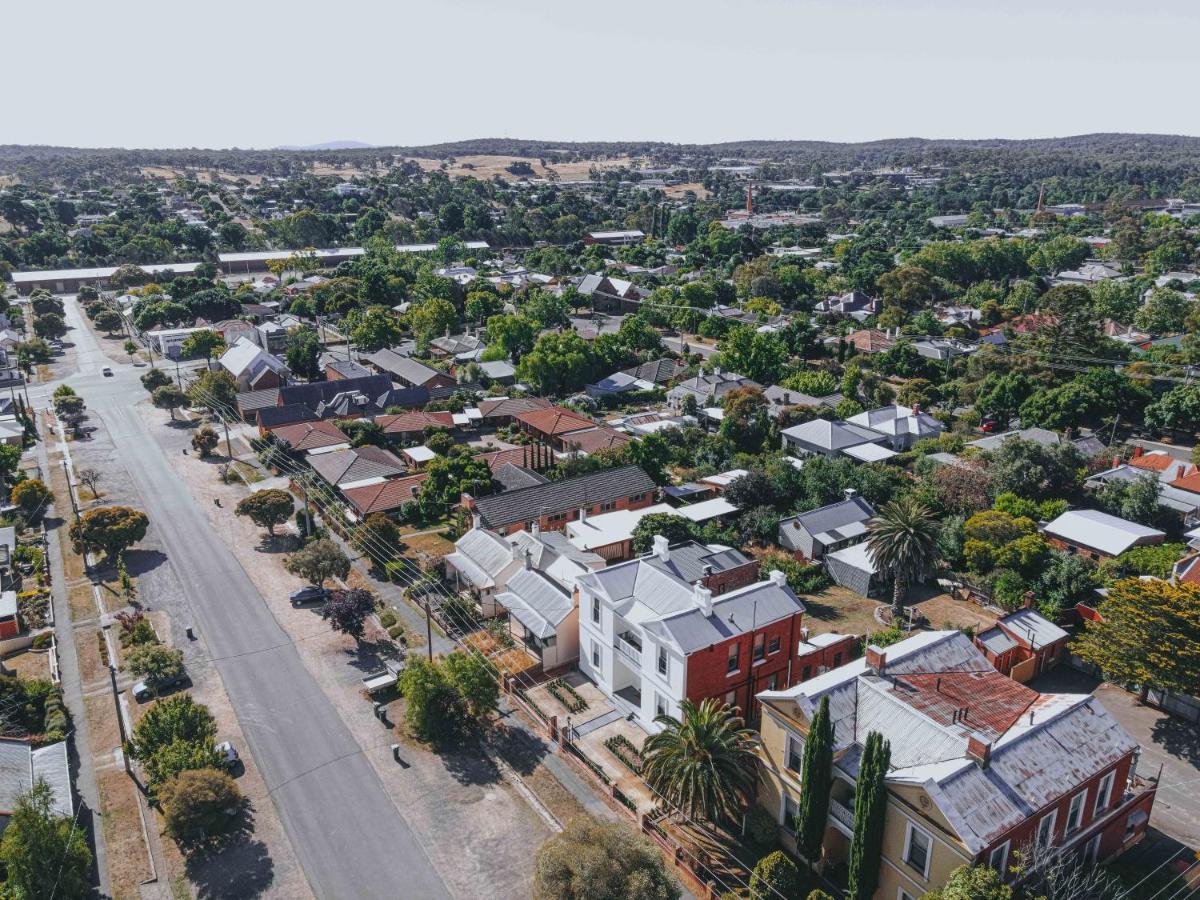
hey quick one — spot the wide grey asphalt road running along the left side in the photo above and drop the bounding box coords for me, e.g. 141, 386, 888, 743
43, 300, 449, 899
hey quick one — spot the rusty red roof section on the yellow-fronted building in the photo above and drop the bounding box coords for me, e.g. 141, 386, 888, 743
893, 671, 1038, 740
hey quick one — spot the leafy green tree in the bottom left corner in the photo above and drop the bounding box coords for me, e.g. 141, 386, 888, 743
0, 779, 91, 900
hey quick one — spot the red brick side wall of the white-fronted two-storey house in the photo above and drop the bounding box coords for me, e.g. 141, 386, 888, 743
684, 612, 804, 719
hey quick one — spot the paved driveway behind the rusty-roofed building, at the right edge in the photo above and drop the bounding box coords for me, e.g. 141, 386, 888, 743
1030, 666, 1200, 848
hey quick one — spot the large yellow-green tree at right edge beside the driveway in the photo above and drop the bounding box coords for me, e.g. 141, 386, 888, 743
1072, 578, 1200, 702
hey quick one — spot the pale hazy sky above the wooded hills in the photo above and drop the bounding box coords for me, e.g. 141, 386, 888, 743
9, 0, 1200, 148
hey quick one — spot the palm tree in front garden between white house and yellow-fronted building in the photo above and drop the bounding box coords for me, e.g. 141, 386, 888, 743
642, 698, 756, 822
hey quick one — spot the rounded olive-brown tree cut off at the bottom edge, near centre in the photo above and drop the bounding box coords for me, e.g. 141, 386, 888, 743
533, 816, 683, 900
